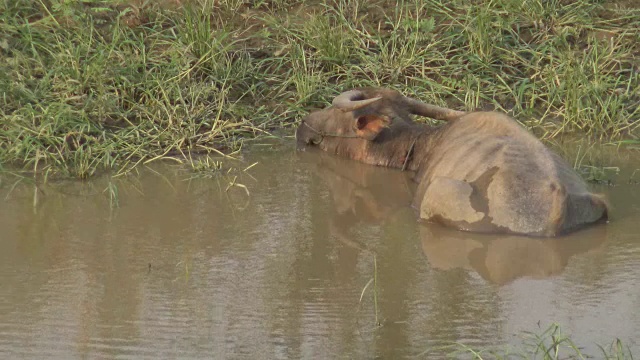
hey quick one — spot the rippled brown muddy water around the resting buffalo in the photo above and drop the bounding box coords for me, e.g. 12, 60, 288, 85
0, 144, 640, 359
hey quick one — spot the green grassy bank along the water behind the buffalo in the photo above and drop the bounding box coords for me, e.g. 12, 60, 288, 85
0, 0, 640, 178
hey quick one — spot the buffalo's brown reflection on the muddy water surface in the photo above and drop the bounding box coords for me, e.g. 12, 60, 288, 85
302, 149, 607, 285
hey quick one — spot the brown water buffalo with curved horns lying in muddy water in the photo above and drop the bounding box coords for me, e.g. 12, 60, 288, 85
296, 88, 608, 237
